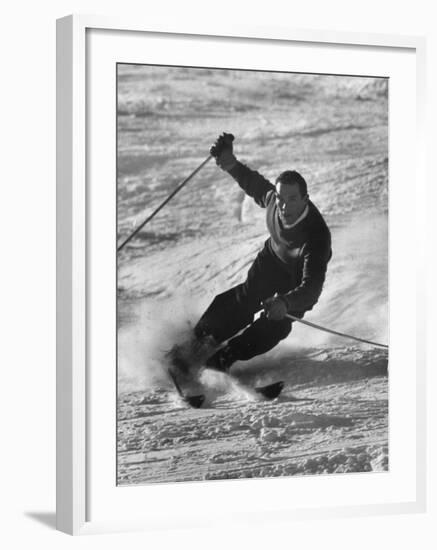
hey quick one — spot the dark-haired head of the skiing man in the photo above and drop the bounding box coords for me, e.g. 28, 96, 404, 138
276, 170, 309, 225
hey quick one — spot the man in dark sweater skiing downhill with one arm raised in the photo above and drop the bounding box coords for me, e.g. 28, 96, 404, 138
172, 134, 331, 372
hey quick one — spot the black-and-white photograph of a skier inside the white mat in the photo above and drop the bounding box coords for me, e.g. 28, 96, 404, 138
116, 63, 389, 486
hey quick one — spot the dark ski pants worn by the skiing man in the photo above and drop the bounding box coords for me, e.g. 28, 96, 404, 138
194, 244, 304, 361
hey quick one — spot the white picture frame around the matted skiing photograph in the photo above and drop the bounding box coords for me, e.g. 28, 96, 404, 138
56, 15, 426, 534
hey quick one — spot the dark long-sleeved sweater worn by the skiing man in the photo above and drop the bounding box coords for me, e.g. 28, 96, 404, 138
229, 162, 332, 312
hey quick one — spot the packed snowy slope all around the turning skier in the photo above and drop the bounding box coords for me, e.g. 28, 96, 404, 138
117, 65, 388, 484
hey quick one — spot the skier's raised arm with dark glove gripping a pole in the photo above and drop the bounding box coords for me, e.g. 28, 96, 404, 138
210, 133, 275, 208
